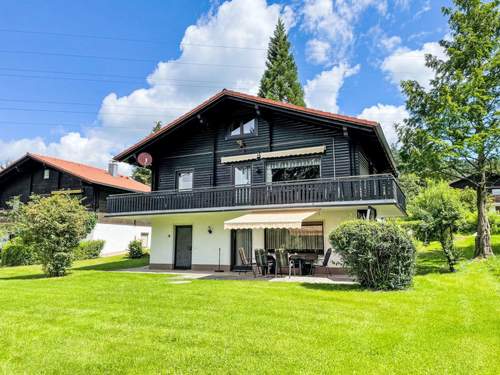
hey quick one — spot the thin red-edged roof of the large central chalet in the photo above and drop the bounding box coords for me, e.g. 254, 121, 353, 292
115, 89, 379, 160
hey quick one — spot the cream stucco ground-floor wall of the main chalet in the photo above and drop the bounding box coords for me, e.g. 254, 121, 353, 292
146, 208, 357, 269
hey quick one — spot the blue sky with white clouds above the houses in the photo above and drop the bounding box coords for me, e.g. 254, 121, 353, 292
0, 0, 448, 170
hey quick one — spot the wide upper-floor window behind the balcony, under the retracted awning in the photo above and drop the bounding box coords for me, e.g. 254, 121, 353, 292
266, 158, 321, 183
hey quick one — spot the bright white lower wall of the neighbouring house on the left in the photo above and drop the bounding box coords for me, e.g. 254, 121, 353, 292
87, 223, 151, 256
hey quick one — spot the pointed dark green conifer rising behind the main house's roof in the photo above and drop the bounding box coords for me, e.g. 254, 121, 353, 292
259, 18, 306, 107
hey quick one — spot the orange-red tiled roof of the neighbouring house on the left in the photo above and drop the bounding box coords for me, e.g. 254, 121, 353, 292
0, 153, 151, 192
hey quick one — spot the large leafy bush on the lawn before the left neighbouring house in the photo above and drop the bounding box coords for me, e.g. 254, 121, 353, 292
10, 194, 96, 277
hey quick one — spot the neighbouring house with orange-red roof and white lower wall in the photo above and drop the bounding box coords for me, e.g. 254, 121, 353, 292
0, 153, 151, 253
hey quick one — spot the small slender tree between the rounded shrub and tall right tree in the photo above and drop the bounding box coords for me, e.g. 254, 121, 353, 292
408, 181, 466, 272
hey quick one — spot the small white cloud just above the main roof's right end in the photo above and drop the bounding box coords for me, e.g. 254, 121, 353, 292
358, 103, 408, 144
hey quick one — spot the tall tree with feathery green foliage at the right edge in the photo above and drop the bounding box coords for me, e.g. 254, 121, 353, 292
398, 0, 500, 257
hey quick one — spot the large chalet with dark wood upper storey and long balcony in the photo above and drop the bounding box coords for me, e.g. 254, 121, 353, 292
107, 90, 405, 271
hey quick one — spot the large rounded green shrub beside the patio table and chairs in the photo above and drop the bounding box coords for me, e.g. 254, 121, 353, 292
330, 220, 416, 290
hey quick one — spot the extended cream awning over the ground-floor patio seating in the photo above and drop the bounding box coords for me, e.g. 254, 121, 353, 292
224, 210, 318, 229
